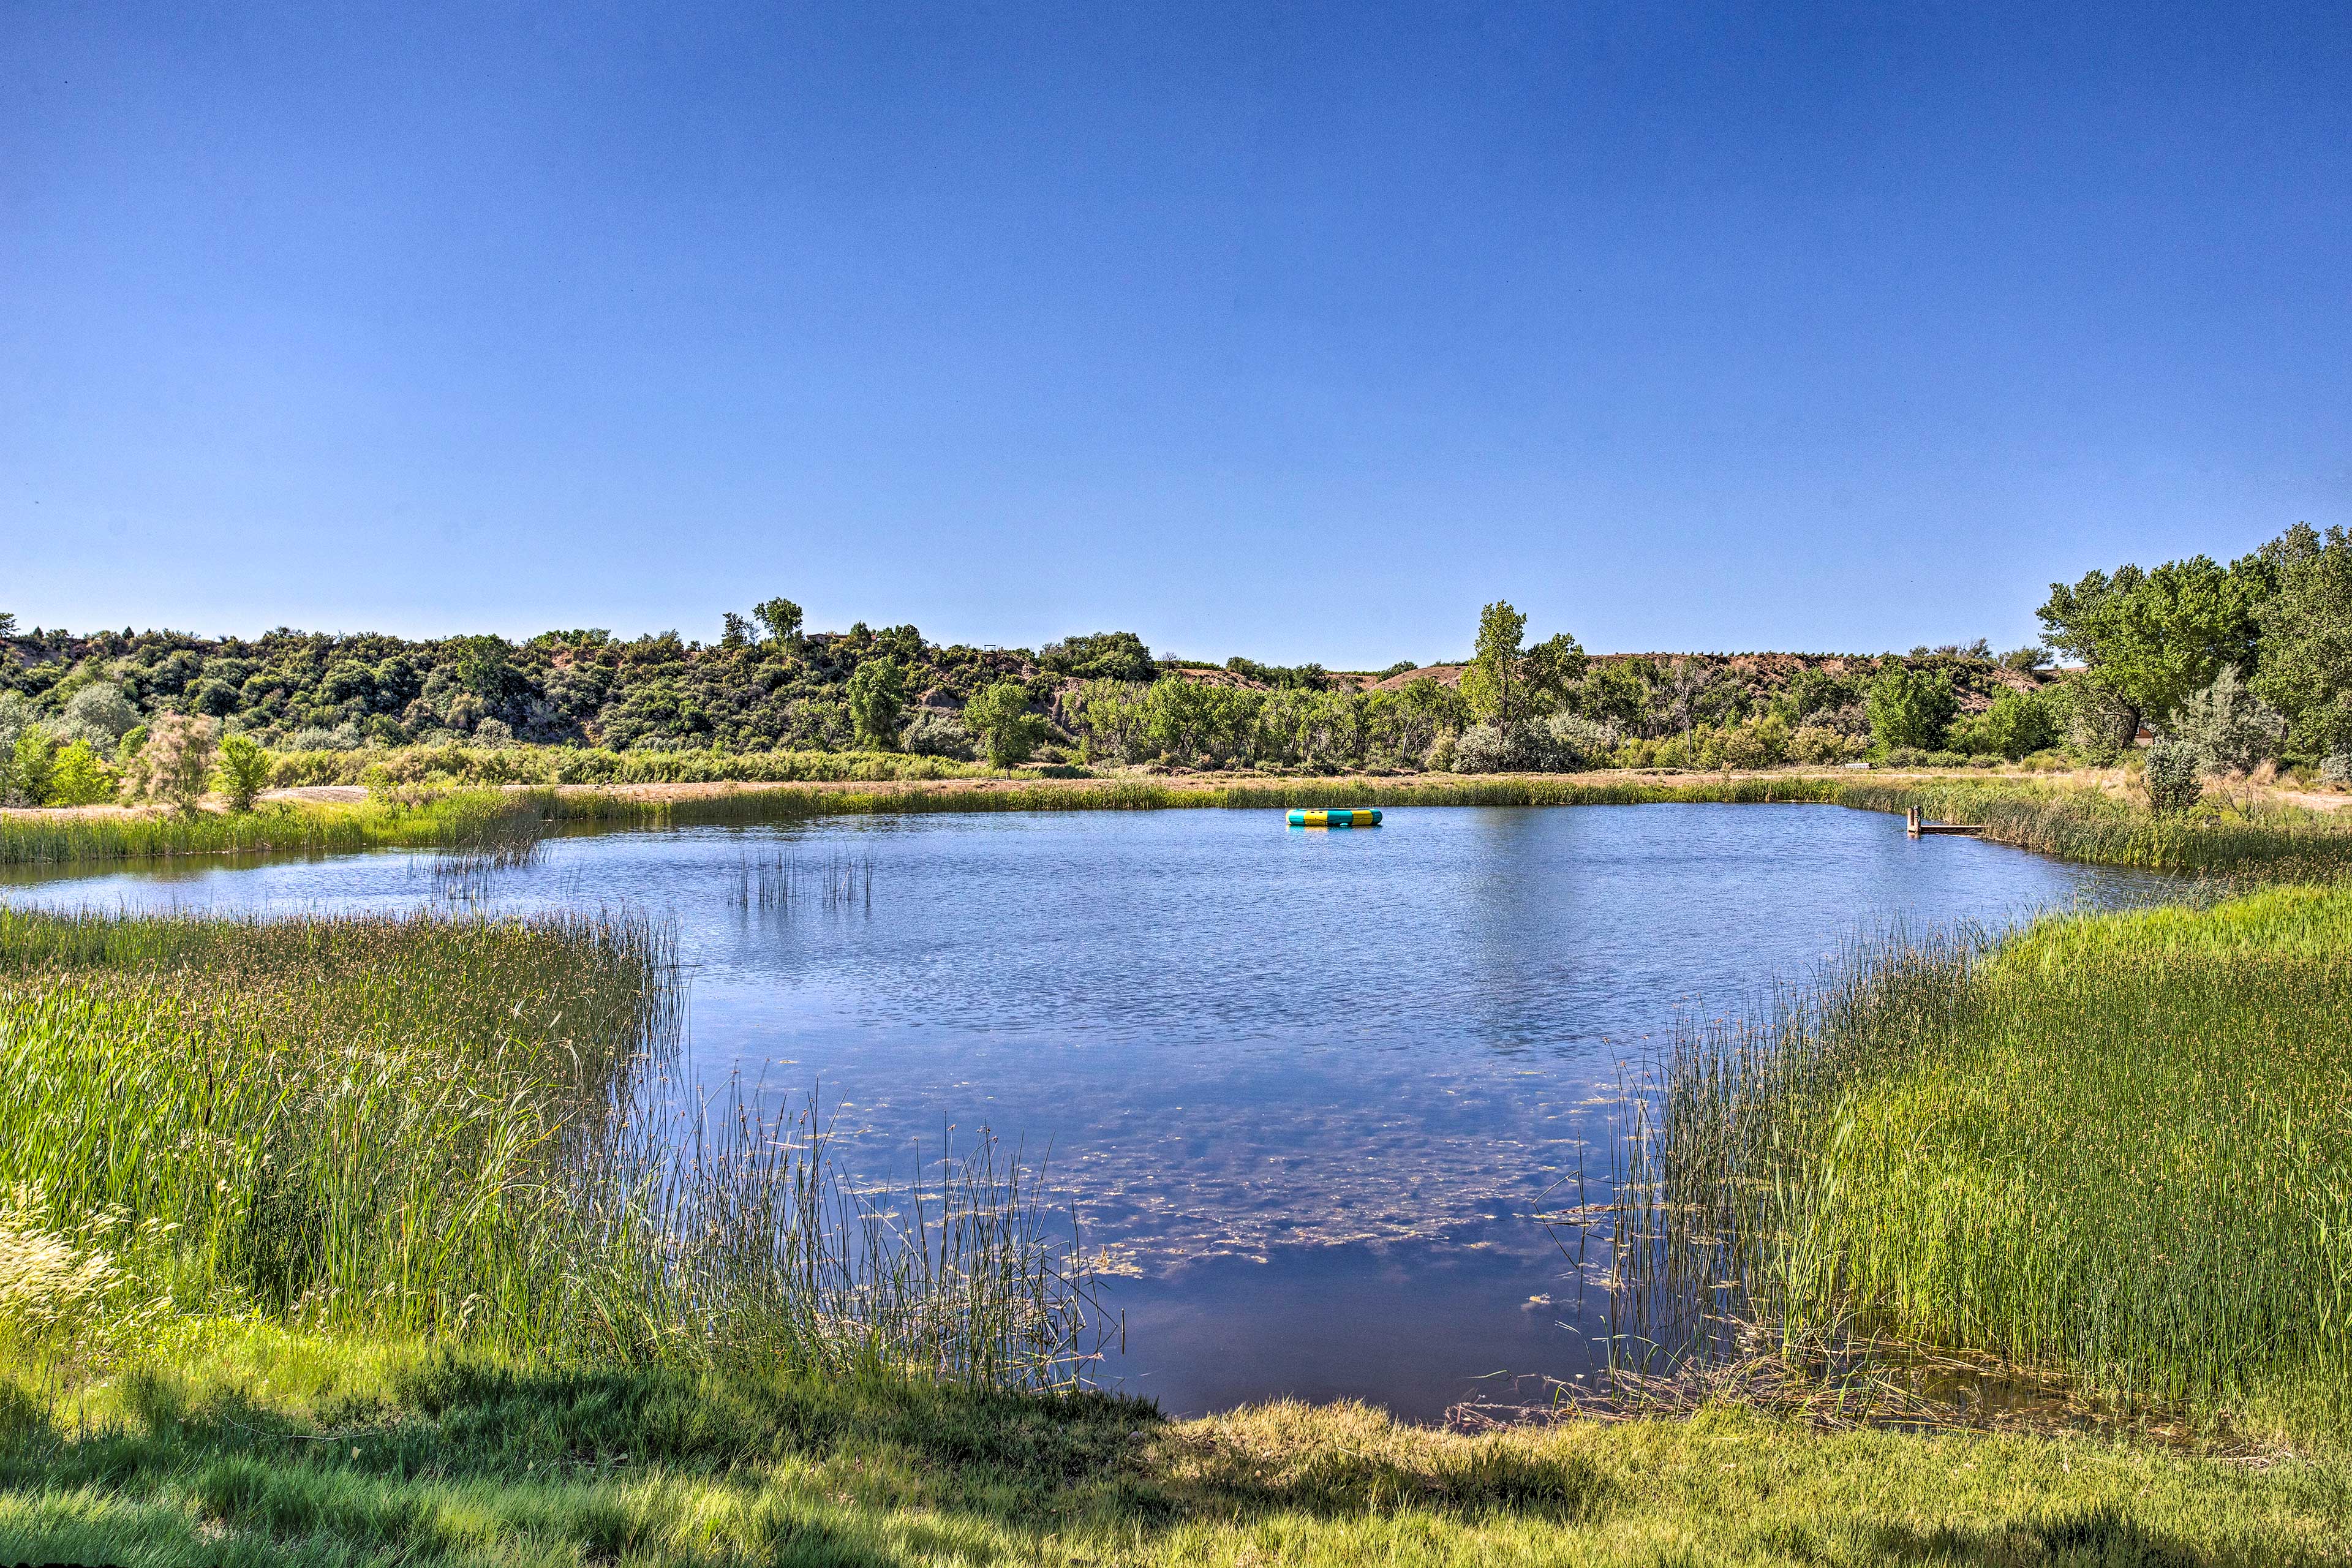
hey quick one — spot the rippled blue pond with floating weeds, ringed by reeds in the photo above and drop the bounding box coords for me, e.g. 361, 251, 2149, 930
0, 806, 2162, 1420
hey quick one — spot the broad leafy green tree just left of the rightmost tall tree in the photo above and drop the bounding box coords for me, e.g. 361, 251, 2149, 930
2037, 555, 2274, 722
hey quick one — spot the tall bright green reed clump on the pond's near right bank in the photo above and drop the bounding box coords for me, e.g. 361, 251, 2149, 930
1621, 886, 2352, 1436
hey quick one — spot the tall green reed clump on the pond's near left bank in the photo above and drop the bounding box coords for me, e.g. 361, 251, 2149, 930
0, 910, 1094, 1382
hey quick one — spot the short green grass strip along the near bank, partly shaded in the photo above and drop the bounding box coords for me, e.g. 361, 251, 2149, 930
0, 1324, 2352, 1568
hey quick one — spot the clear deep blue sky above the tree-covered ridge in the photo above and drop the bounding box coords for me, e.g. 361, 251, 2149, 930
0, 0, 2352, 668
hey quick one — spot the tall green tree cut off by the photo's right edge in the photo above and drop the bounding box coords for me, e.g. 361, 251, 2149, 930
2248, 522, 2352, 757
